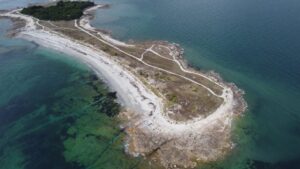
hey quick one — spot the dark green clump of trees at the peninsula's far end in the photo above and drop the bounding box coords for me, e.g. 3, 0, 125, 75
21, 1, 95, 21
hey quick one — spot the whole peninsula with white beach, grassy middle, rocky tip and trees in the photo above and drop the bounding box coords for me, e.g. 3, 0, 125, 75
0, 1, 246, 168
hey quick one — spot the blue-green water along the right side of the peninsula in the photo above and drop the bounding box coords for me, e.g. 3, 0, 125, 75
93, 0, 300, 169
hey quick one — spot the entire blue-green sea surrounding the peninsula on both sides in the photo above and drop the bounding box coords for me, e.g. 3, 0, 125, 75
0, 0, 300, 169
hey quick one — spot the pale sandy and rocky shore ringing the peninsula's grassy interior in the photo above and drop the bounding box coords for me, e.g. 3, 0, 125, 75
2, 5, 247, 168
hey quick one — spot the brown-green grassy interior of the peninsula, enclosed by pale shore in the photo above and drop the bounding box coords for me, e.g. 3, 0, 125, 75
40, 21, 223, 121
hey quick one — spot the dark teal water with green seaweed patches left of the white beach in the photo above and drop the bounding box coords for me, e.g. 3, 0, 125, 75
0, 43, 155, 169
